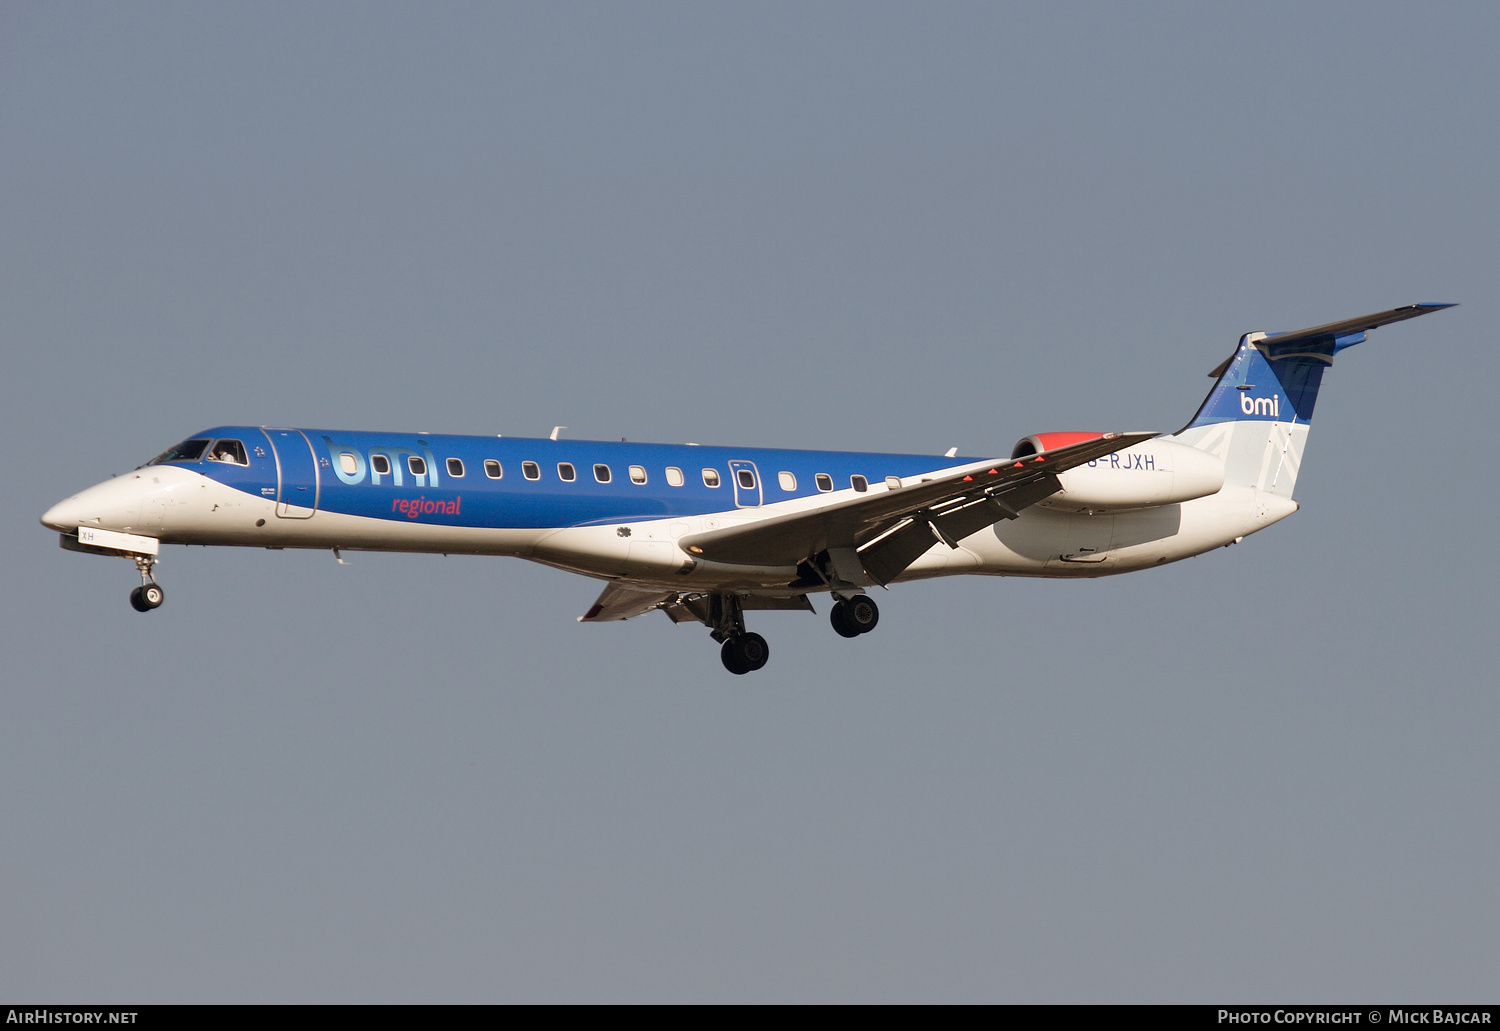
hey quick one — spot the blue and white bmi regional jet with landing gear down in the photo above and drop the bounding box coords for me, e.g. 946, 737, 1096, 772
42, 305, 1452, 674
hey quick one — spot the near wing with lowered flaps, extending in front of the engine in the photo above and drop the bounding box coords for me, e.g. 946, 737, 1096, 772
678, 434, 1157, 584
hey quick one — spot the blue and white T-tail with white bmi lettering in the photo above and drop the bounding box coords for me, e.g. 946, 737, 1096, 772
1172, 305, 1454, 498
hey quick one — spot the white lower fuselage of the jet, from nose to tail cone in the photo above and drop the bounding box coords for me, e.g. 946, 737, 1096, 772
44, 441, 1298, 593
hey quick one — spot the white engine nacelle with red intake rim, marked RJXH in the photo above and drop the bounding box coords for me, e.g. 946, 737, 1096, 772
1011, 432, 1224, 512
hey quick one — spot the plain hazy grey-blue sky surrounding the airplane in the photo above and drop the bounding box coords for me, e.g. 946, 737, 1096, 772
0, 3, 1500, 1001
